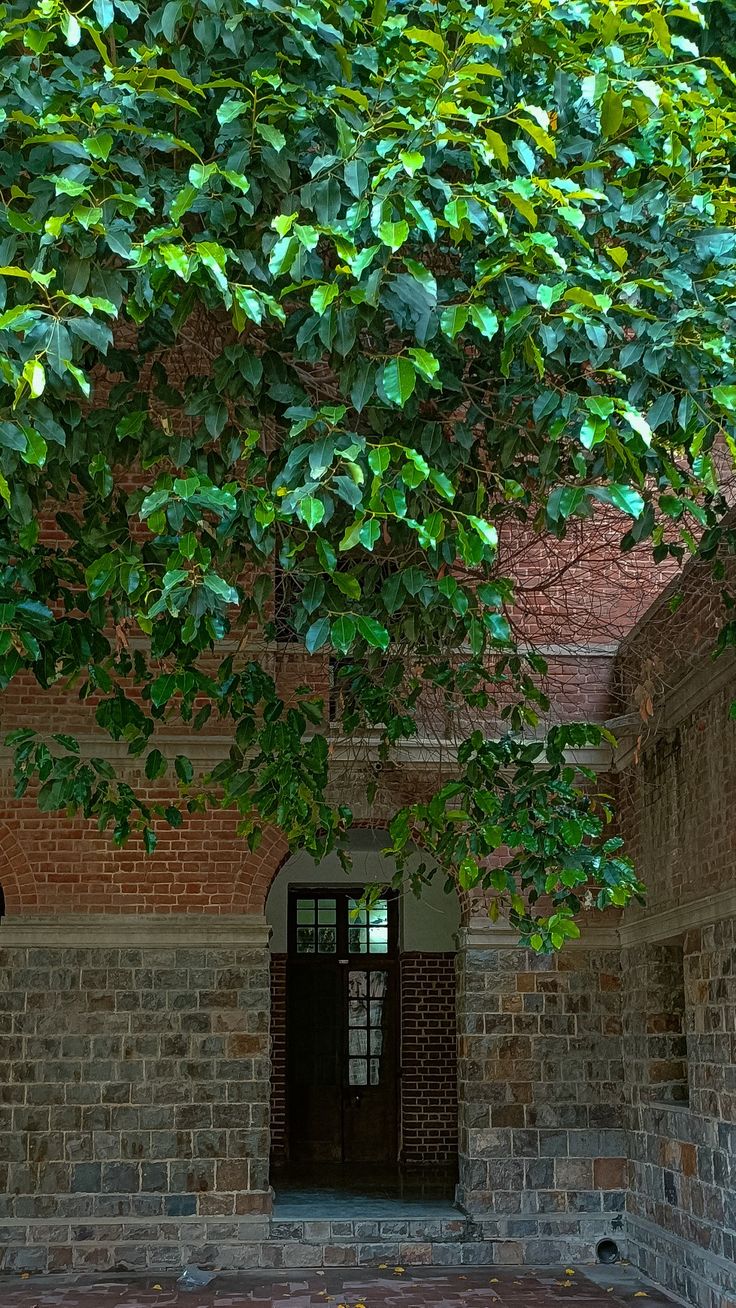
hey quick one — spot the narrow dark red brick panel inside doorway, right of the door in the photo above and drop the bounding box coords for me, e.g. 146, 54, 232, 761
400, 954, 458, 1167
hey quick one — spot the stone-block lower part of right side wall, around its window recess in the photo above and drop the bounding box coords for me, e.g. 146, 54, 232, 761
624, 918, 736, 1308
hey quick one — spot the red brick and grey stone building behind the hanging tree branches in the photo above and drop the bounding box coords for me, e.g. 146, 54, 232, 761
0, 533, 736, 1308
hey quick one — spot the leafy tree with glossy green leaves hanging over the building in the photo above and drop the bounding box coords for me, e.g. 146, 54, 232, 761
0, 0, 736, 948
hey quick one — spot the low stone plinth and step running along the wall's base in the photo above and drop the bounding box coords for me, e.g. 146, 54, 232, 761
0, 1214, 624, 1275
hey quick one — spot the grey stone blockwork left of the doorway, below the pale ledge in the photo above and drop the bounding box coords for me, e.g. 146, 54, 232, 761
0, 947, 269, 1218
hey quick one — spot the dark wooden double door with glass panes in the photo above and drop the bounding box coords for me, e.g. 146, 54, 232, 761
286, 887, 399, 1164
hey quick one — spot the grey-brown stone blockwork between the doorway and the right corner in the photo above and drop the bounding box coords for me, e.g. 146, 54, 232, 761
458, 947, 627, 1245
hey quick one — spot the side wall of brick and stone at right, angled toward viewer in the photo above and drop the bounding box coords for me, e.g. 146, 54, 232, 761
618, 549, 736, 1308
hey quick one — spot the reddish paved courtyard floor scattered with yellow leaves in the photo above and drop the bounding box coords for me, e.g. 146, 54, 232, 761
0, 1265, 673, 1308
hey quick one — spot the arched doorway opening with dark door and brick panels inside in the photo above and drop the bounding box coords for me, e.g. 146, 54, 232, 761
267, 829, 460, 1196
